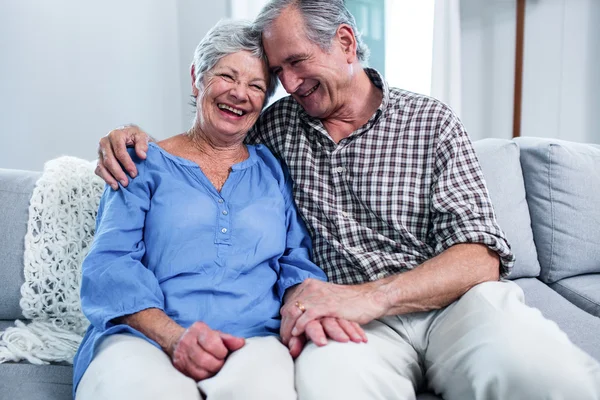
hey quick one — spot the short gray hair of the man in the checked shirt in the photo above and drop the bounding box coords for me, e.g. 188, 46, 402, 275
254, 0, 370, 63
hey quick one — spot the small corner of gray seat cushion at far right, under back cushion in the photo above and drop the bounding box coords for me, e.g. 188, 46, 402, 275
550, 274, 600, 317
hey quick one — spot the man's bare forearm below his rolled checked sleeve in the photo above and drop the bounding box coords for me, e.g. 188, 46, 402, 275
376, 244, 500, 315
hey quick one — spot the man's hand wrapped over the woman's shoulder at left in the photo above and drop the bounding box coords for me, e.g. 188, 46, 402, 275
95, 125, 150, 190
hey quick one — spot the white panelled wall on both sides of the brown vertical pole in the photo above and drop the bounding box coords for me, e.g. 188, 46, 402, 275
461, 0, 600, 143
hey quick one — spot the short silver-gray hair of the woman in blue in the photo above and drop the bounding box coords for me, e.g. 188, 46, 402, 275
191, 20, 277, 107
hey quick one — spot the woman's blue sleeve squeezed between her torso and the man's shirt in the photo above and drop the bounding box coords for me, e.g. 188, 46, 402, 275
277, 168, 327, 302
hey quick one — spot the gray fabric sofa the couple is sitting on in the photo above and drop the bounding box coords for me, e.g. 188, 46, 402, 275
0, 138, 600, 400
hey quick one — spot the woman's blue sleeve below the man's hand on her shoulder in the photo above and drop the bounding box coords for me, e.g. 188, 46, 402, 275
81, 153, 164, 331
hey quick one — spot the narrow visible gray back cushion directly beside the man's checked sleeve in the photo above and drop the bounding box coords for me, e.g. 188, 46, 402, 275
474, 139, 540, 279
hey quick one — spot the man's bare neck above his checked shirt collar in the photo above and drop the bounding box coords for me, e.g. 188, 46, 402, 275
321, 69, 383, 143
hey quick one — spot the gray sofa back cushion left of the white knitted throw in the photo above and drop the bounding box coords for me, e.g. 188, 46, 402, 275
0, 169, 41, 319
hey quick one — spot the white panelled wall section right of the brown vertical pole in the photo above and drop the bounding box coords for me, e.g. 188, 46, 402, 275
521, 0, 600, 143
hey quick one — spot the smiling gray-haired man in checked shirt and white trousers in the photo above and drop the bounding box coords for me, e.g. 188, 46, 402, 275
97, 0, 600, 400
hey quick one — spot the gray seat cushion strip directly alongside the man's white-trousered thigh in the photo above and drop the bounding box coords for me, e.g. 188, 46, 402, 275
515, 278, 600, 361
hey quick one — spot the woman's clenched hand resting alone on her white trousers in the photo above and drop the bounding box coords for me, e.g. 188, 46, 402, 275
167, 322, 245, 381
